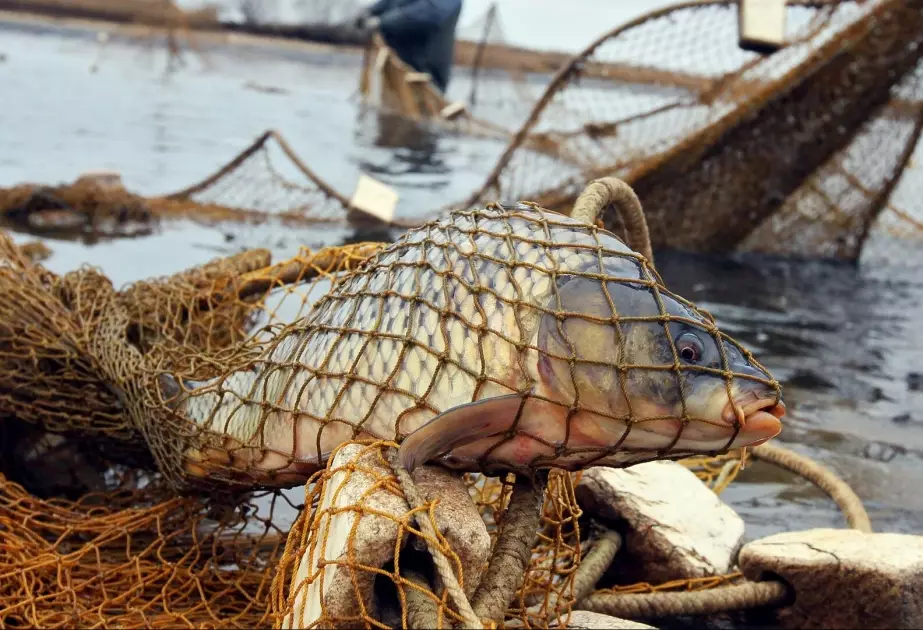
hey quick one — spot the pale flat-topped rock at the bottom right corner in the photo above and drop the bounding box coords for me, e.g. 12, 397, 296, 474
739, 529, 923, 628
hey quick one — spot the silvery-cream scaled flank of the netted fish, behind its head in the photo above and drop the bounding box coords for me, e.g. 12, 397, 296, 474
181, 204, 641, 466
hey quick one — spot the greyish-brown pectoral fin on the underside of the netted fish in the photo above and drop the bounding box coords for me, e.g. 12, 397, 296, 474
398, 394, 524, 471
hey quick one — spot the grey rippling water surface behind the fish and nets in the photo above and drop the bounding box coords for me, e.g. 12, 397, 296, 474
0, 16, 923, 537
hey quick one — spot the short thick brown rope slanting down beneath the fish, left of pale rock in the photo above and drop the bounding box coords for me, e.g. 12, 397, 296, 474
473, 471, 547, 622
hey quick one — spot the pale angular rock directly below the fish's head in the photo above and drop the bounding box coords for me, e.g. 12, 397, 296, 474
576, 461, 744, 582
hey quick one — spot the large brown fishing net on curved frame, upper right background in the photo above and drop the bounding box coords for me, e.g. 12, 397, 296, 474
459, 0, 923, 259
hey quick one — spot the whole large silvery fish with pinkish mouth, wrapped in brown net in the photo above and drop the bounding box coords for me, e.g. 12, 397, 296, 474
161, 203, 785, 483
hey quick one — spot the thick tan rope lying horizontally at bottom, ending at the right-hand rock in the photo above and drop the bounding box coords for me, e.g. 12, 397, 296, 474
575, 581, 789, 619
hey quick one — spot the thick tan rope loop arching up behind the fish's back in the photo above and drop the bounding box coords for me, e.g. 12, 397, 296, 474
570, 177, 654, 265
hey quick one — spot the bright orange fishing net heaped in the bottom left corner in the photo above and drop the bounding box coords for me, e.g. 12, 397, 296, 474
0, 476, 297, 628
